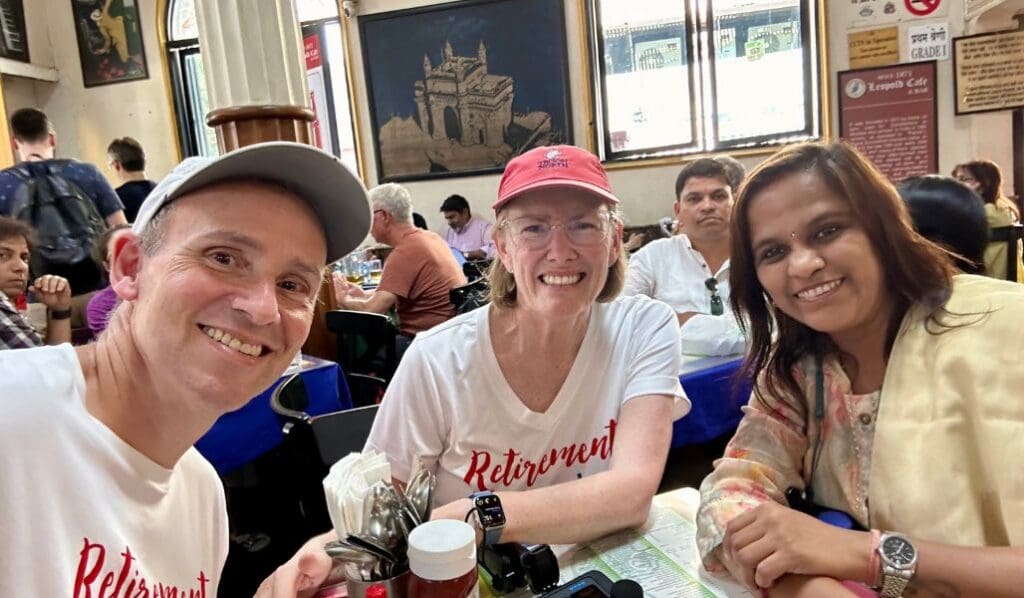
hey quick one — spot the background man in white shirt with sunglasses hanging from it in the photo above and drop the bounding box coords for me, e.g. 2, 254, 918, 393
623, 158, 745, 355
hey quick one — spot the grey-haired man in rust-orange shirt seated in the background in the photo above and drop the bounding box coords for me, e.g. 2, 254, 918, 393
335, 183, 466, 337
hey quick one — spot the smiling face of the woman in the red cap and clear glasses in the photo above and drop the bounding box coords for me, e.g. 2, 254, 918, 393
496, 188, 622, 315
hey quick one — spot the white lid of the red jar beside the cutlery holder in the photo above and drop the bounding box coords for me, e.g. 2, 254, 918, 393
408, 519, 476, 581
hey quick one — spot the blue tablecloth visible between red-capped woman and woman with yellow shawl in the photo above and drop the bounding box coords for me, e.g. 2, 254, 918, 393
672, 356, 751, 447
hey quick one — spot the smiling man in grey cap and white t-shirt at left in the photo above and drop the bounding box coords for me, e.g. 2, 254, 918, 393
0, 142, 371, 597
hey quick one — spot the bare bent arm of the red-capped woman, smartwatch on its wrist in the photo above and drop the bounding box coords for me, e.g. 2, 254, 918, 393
433, 395, 673, 544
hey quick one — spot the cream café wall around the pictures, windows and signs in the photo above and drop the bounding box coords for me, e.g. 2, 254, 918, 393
4, 0, 1020, 229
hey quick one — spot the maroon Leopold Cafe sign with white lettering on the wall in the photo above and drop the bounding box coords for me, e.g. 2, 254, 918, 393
839, 60, 939, 182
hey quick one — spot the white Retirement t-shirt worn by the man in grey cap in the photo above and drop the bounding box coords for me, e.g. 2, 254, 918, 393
0, 344, 228, 598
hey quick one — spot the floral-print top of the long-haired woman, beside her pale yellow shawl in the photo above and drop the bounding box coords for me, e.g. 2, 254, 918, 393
697, 357, 880, 575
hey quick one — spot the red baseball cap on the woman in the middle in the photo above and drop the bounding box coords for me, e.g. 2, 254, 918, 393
492, 145, 618, 213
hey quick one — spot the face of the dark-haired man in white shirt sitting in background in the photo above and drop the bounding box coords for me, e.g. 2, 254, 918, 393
673, 176, 733, 243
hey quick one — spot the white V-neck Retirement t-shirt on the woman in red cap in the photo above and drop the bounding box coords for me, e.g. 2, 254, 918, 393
367, 297, 689, 505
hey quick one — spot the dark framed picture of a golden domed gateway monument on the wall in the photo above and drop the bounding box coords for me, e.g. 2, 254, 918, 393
359, 0, 572, 182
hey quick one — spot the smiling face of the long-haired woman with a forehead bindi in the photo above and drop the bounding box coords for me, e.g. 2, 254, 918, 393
748, 172, 892, 346
